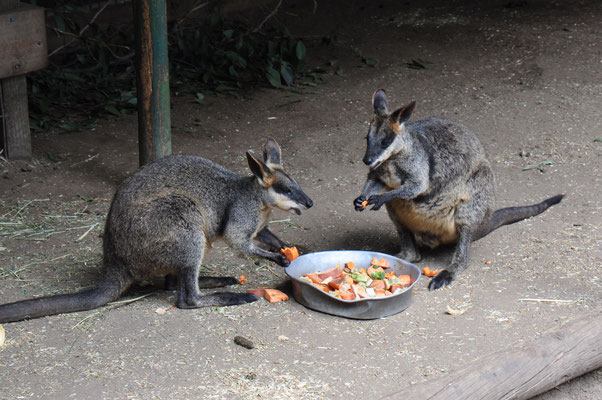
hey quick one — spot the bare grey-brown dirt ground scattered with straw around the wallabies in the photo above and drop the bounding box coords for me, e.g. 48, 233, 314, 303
0, 0, 602, 400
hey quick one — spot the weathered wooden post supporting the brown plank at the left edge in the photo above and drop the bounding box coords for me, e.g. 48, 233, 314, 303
0, 0, 32, 160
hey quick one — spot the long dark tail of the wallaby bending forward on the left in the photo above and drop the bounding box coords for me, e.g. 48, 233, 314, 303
0, 277, 129, 323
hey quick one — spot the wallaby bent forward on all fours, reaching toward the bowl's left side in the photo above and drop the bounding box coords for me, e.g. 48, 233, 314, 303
0, 139, 313, 322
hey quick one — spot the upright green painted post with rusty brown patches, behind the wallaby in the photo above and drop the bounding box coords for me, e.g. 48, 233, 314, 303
132, 0, 171, 165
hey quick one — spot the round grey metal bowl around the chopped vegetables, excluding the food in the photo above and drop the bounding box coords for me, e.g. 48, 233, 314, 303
285, 250, 420, 319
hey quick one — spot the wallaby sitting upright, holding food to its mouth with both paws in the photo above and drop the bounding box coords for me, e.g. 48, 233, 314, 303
353, 89, 563, 290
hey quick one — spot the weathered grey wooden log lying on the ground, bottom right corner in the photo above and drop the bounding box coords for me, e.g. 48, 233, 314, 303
385, 309, 602, 400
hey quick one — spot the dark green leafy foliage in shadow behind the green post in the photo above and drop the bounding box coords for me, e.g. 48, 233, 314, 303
28, 0, 320, 132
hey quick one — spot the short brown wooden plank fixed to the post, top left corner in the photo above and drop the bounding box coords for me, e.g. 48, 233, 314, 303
0, 6, 48, 78
